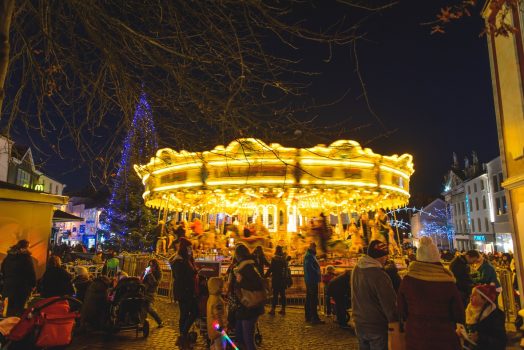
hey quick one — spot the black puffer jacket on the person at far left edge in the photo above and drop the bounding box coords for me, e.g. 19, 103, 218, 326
1, 249, 36, 296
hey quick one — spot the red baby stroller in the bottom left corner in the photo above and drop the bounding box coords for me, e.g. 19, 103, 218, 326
1, 297, 81, 350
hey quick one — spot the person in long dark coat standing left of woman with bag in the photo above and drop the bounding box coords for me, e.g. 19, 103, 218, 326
171, 237, 198, 348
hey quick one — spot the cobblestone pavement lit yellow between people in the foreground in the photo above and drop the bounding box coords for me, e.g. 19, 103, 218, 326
68, 301, 358, 350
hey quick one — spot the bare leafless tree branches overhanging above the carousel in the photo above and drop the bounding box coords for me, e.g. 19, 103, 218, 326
0, 0, 392, 185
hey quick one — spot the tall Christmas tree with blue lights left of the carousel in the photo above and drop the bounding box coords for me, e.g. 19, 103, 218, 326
101, 93, 158, 251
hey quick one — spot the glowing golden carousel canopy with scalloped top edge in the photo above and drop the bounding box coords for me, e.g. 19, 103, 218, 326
134, 138, 414, 215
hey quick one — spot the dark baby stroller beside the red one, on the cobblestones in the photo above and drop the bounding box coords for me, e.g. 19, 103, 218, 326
108, 277, 149, 337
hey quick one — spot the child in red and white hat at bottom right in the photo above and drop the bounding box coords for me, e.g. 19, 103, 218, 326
463, 284, 507, 350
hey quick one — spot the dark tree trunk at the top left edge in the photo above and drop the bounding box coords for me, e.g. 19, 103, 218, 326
0, 0, 15, 118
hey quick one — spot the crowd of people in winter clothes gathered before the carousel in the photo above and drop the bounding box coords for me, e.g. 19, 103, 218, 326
0, 231, 512, 350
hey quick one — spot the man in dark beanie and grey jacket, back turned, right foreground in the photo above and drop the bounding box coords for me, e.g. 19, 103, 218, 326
351, 240, 398, 350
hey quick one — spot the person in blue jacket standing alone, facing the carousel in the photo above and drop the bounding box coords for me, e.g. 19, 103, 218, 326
304, 243, 325, 324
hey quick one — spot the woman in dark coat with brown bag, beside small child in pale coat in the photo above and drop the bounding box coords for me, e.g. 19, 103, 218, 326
233, 244, 264, 350
